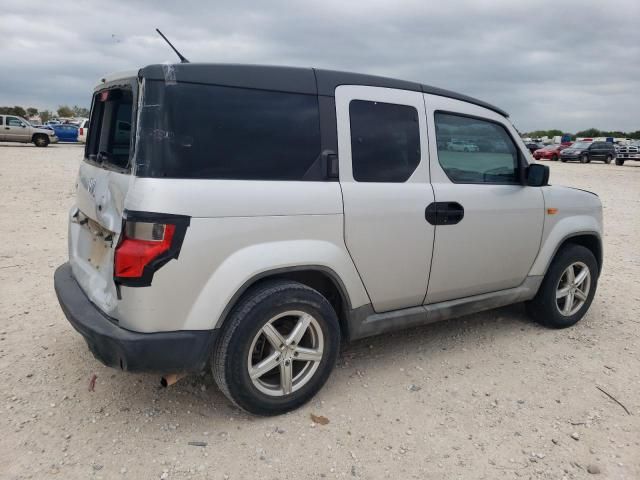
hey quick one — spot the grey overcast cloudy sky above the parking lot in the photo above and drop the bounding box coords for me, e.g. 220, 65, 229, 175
0, 0, 640, 132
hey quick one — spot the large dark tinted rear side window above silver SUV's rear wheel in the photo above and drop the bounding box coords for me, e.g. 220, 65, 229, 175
138, 80, 321, 180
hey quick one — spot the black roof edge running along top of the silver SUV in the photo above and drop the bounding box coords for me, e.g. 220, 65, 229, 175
139, 63, 509, 117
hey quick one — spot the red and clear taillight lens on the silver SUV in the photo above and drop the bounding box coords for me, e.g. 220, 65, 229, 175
115, 222, 176, 278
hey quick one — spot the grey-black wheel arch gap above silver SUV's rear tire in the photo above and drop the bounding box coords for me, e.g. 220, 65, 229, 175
221, 267, 351, 338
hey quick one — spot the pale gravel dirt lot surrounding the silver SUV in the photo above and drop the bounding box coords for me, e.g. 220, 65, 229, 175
0, 144, 640, 480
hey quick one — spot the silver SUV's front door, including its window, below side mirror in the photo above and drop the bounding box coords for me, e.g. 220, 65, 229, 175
425, 95, 544, 304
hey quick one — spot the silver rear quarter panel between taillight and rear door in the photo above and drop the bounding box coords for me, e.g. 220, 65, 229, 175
113, 178, 369, 332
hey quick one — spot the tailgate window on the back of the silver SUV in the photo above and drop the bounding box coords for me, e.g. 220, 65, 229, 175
85, 89, 133, 169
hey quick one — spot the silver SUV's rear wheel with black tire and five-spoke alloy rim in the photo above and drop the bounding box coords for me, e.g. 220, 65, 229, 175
211, 280, 340, 415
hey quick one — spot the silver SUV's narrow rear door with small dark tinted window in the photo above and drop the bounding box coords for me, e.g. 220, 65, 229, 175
335, 85, 435, 312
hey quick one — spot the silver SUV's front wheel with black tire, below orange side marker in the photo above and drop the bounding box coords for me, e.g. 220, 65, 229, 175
527, 243, 599, 328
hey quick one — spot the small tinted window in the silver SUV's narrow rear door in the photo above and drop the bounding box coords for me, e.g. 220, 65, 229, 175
349, 100, 420, 183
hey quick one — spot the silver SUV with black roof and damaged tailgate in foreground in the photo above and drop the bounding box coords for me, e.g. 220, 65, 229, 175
55, 64, 602, 415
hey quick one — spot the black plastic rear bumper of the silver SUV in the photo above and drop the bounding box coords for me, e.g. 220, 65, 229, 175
54, 263, 218, 373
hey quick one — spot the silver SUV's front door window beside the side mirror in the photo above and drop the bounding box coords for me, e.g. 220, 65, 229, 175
435, 112, 519, 183
